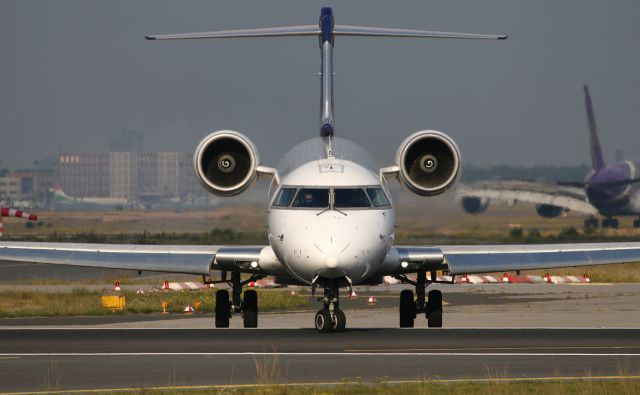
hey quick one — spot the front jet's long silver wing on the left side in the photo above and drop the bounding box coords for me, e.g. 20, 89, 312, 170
0, 242, 270, 275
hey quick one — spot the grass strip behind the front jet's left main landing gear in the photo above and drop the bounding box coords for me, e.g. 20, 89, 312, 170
0, 288, 309, 318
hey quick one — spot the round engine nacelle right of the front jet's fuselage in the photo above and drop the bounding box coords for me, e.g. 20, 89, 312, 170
396, 130, 460, 196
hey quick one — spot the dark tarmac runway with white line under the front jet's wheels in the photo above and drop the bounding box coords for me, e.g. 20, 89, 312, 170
0, 328, 640, 392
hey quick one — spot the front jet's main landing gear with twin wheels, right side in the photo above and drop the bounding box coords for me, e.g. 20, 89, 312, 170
396, 272, 442, 328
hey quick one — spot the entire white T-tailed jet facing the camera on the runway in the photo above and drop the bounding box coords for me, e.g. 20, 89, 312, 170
0, 8, 640, 332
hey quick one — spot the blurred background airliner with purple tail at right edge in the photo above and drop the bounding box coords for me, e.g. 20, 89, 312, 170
457, 85, 640, 229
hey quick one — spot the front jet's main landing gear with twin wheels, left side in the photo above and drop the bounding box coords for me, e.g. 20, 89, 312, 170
215, 272, 262, 328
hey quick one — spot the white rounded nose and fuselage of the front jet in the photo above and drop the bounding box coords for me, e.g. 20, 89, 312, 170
268, 157, 395, 284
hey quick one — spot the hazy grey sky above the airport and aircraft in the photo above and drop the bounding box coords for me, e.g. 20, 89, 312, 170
0, 0, 640, 168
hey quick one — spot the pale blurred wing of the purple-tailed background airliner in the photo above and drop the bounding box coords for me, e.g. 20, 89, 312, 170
457, 181, 598, 215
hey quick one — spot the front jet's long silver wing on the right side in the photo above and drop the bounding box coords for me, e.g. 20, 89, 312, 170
394, 242, 640, 274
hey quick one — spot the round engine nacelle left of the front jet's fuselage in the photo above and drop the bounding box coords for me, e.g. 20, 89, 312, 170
193, 130, 260, 197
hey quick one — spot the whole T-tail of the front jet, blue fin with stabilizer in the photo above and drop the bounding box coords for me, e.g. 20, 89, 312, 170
146, 7, 507, 145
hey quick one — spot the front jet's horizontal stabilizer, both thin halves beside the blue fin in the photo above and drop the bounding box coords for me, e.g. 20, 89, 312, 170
145, 25, 508, 40
